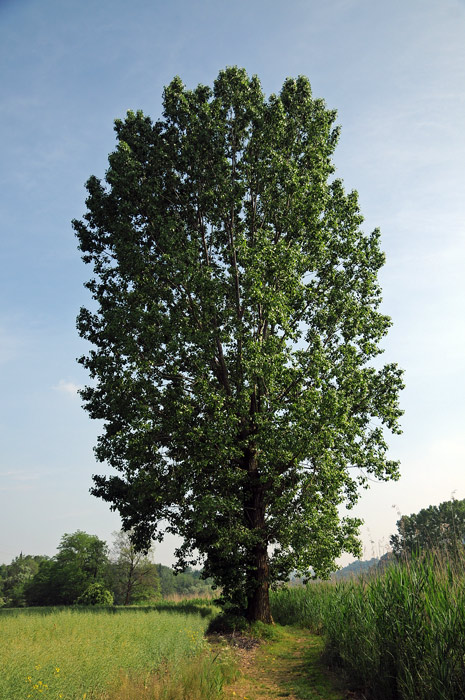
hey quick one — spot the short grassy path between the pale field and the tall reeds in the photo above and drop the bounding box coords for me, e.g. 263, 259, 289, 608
216, 626, 351, 700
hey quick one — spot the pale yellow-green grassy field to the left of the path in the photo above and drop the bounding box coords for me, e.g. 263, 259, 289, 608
0, 604, 230, 700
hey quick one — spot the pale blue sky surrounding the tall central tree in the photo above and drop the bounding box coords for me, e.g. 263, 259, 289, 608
0, 0, 465, 564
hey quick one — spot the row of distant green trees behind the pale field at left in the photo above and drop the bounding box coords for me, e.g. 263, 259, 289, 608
0, 530, 211, 607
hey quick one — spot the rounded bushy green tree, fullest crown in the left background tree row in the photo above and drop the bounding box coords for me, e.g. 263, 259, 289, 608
25, 530, 108, 605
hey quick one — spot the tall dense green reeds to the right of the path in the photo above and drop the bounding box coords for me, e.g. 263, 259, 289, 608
272, 554, 465, 700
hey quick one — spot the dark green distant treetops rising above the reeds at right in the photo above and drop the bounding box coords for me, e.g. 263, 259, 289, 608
390, 499, 465, 557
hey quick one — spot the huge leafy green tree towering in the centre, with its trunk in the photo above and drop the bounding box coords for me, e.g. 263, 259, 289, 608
73, 68, 402, 621
